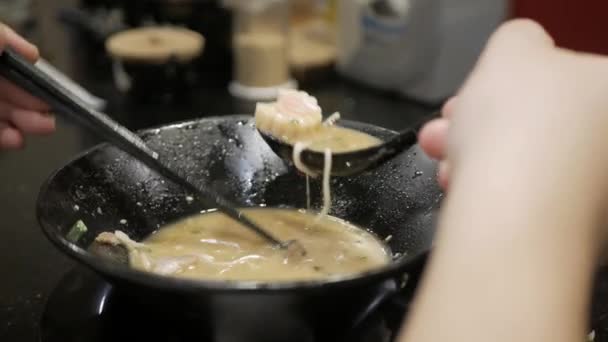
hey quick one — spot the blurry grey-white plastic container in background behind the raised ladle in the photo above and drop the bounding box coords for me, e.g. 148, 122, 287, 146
338, 0, 508, 103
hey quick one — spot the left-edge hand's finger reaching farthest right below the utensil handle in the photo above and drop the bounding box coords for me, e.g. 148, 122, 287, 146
0, 102, 55, 134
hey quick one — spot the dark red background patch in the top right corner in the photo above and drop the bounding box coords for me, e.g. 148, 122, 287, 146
513, 0, 608, 54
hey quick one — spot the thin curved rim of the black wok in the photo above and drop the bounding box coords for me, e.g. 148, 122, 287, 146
36, 114, 431, 292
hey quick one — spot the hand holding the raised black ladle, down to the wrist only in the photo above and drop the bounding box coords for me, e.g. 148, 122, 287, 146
420, 20, 608, 203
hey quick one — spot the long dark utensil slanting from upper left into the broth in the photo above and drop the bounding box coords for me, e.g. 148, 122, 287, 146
0, 49, 305, 254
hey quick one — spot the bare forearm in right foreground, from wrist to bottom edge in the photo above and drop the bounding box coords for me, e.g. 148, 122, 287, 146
402, 165, 599, 342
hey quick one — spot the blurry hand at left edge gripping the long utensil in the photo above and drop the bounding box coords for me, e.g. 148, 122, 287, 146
0, 23, 55, 150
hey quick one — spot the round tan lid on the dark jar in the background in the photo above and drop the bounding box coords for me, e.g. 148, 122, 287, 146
106, 26, 205, 63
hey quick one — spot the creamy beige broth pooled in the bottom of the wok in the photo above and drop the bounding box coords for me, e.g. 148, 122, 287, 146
131, 209, 390, 281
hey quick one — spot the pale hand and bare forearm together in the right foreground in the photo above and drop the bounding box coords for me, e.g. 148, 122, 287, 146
401, 20, 608, 342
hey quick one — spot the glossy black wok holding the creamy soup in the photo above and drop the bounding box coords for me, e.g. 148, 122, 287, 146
37, 116, 441, 341
